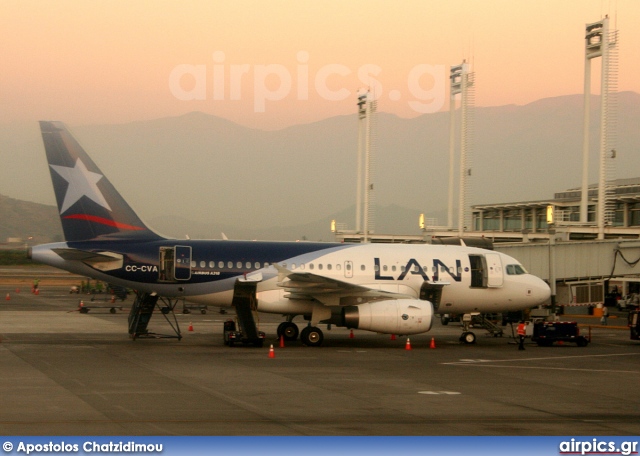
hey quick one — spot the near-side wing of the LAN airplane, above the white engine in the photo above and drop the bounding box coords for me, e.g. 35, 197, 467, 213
274, 264, 416, 306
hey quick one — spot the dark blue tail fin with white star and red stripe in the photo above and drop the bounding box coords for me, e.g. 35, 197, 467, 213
40, 121, 161, 241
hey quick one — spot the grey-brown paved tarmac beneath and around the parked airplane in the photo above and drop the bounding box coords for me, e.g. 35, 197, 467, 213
0, 282, 640, 436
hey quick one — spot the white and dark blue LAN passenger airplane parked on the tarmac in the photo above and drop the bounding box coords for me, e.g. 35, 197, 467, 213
29, 121, 550, 346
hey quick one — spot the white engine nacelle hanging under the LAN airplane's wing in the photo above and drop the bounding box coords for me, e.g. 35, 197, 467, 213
342, 299, 433, 335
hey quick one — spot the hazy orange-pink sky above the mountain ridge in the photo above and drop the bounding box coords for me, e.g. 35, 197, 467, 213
0, 0, 640, 129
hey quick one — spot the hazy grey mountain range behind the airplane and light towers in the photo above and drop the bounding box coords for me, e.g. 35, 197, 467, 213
0, 92, 640, 244
